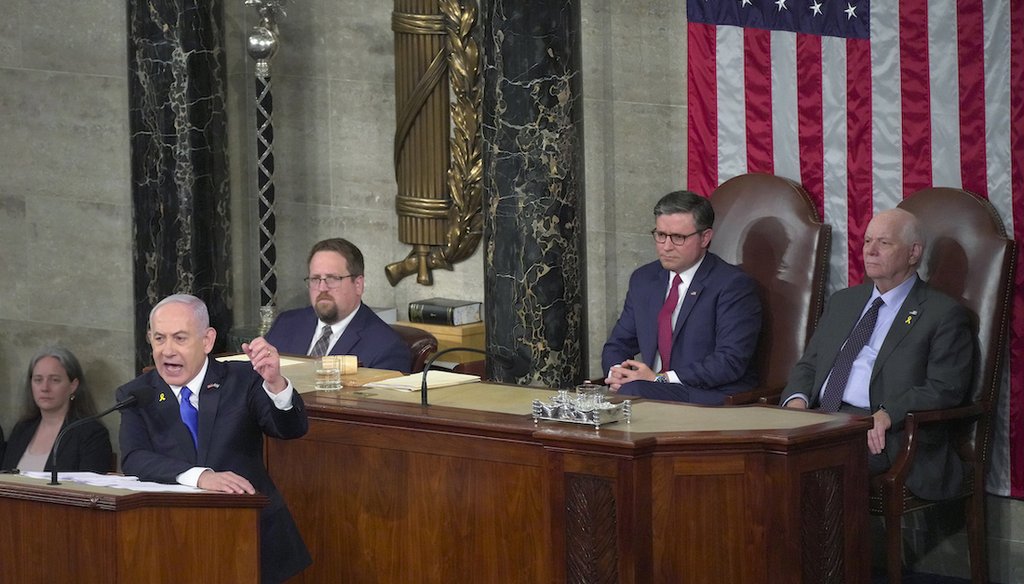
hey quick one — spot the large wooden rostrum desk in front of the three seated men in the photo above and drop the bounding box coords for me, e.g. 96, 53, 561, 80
267, 364, 870, 584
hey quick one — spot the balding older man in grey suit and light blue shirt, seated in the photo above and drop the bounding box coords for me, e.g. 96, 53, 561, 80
782, 209, 975, 499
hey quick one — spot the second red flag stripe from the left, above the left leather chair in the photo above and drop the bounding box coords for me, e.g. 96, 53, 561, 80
743, 29, 775, 174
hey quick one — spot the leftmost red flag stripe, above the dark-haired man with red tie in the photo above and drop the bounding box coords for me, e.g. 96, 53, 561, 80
686, 24, 718, 196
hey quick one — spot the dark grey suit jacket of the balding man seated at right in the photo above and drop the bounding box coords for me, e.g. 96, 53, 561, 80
782, 280, 975, 499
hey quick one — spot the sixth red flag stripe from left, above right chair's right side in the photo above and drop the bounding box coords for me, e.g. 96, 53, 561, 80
956, 2, 988, 199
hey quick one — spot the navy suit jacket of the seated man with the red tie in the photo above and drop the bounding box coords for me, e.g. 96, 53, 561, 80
601, 252, 761, 404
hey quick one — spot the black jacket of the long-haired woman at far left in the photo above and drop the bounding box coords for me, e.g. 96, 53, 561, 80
0, 418, 114, 473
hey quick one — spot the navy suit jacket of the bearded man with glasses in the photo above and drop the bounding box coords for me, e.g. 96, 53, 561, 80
266, 303, 413, 373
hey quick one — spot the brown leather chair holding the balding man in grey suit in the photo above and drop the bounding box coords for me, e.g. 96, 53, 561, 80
869, 187, 1017, 584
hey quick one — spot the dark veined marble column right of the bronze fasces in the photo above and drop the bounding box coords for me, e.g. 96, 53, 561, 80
480, 0, 588, 387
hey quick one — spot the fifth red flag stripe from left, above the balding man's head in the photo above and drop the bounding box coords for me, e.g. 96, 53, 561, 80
899, 0, 932, 197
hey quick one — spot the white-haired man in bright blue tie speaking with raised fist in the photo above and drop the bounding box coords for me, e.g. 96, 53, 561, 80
117, 294, 311, 582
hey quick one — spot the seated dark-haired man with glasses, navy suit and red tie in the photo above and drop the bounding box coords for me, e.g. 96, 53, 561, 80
601, 191, 761, 404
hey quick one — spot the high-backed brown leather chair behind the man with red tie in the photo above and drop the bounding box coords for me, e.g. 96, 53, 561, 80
710, 173, 831, 405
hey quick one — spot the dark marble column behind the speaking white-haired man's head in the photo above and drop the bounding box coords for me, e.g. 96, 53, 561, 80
128, 0, 231, 367
